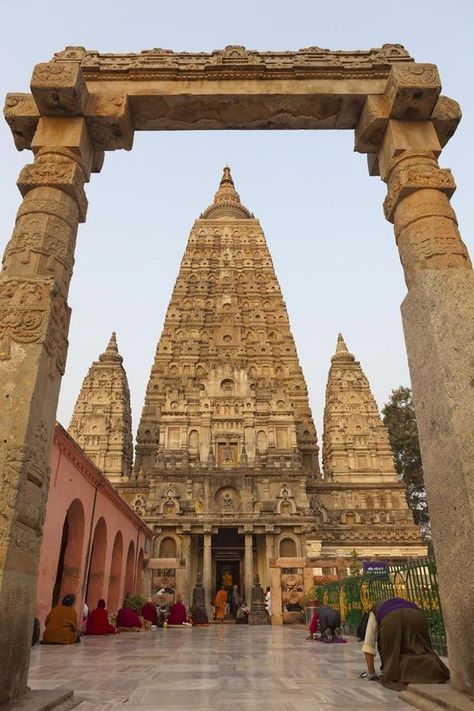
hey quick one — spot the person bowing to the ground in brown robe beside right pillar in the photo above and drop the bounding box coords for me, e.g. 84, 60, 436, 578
362, 597, 449, 690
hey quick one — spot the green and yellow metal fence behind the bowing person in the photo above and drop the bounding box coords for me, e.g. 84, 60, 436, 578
316, 557, 446, 655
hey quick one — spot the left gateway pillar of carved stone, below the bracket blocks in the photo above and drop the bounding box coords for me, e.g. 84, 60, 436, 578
0, 108, 93, 704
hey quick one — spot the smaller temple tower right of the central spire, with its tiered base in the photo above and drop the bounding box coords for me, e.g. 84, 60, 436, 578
310, 334, 425, 558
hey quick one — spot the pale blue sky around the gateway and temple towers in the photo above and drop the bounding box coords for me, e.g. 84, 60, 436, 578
0, 0, 474, 454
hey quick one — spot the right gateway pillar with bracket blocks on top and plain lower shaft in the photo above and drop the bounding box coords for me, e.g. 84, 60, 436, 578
356, 65, 474, 695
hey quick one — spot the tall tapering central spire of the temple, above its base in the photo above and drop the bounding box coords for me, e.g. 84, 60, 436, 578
131, 168, 318, 478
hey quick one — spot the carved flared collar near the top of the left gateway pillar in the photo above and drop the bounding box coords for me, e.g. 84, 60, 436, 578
17, 159, 87, 222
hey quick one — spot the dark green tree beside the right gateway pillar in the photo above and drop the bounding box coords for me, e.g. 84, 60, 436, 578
382, 385, 431, 539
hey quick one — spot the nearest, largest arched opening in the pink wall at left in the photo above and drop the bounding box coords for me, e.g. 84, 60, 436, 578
51, 499, 85, 607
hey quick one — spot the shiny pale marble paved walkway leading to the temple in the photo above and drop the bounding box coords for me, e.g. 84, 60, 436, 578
29, 625, 410, 711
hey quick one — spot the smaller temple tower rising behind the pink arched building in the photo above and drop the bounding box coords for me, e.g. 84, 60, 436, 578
68, 333, 132, 484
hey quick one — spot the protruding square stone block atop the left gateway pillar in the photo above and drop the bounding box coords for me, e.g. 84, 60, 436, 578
30, 62, 88, 116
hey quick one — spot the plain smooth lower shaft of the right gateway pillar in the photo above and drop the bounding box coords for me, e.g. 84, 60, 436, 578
402, 269, 474, 695
